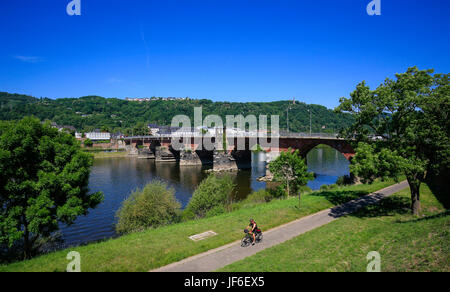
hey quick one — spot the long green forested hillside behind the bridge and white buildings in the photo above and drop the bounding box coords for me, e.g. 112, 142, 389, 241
0, 92, 352, 132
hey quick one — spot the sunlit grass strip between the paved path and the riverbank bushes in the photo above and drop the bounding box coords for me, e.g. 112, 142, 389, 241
0, 181, 400, 272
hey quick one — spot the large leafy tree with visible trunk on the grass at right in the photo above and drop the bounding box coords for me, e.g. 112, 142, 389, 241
336, 67, 450, 215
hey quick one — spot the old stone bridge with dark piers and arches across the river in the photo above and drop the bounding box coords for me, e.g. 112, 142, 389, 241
125, 133, 355, 170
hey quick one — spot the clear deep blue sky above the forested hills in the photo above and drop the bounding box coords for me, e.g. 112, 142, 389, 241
0, 0, 450, 108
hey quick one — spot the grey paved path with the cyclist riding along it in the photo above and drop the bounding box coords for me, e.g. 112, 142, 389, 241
152, 181, 408, 272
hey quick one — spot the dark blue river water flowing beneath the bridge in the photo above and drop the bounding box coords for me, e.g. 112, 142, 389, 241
61, 145, 349, 247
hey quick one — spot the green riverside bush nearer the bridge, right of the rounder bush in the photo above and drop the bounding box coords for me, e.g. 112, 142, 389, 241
183, 174, 235, 218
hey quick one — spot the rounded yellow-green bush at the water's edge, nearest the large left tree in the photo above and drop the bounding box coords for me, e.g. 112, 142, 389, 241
116, 182, 181, 234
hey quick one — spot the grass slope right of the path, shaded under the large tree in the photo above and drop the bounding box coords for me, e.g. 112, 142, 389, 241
220, 185, 450, 272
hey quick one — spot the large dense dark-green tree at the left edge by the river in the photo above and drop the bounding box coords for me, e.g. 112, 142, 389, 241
0, 117, 103, 258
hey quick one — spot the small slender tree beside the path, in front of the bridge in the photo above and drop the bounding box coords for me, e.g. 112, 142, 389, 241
269, 149, 314, 205
